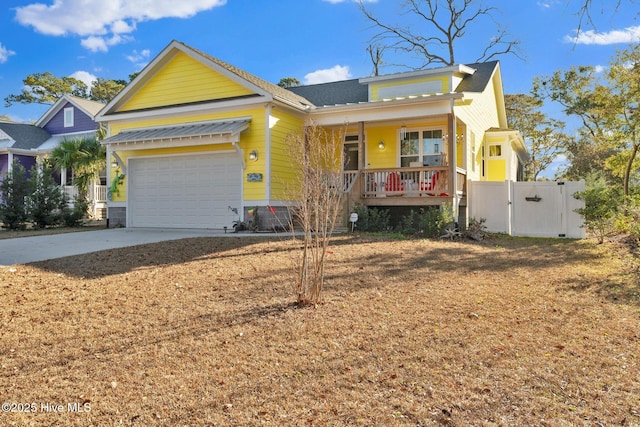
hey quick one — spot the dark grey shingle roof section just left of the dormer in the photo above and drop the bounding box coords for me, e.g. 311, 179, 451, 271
288, 79, 369, 106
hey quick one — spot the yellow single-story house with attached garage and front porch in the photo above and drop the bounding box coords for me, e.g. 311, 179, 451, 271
97, 41, 527, 228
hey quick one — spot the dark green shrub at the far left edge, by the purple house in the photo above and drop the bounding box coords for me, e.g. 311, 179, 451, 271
0, 161, 31, 230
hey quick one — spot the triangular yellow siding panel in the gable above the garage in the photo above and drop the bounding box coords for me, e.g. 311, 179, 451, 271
120, 52, 253, 111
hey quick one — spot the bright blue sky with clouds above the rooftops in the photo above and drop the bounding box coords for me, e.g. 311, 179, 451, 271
0, 0, 640, 127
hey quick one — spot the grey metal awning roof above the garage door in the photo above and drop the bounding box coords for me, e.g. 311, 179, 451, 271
102, 119, 250, 149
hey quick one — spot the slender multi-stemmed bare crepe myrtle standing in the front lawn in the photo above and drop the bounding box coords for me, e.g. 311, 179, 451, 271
287, 122, 344, 306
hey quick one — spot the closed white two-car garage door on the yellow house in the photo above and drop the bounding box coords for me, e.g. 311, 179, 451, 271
127, 153, 242, 228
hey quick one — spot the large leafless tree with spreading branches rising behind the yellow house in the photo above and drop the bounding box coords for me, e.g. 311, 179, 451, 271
359, 0, 520, 68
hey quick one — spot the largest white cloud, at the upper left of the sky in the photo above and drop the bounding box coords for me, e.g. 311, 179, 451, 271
16, 0, 227, 52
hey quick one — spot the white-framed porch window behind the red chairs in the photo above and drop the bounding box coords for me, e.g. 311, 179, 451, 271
400, 129, 442, 167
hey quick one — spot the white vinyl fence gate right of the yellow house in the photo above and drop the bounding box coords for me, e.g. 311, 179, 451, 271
468, 181, 585, 239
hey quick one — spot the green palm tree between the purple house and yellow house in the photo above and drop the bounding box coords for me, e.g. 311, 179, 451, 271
51, 137, 107, 200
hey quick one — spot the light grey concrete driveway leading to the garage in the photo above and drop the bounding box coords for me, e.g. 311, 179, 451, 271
0, 228, 258, 266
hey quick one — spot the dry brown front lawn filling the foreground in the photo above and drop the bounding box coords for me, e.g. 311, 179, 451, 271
0, 236, 640, 426
